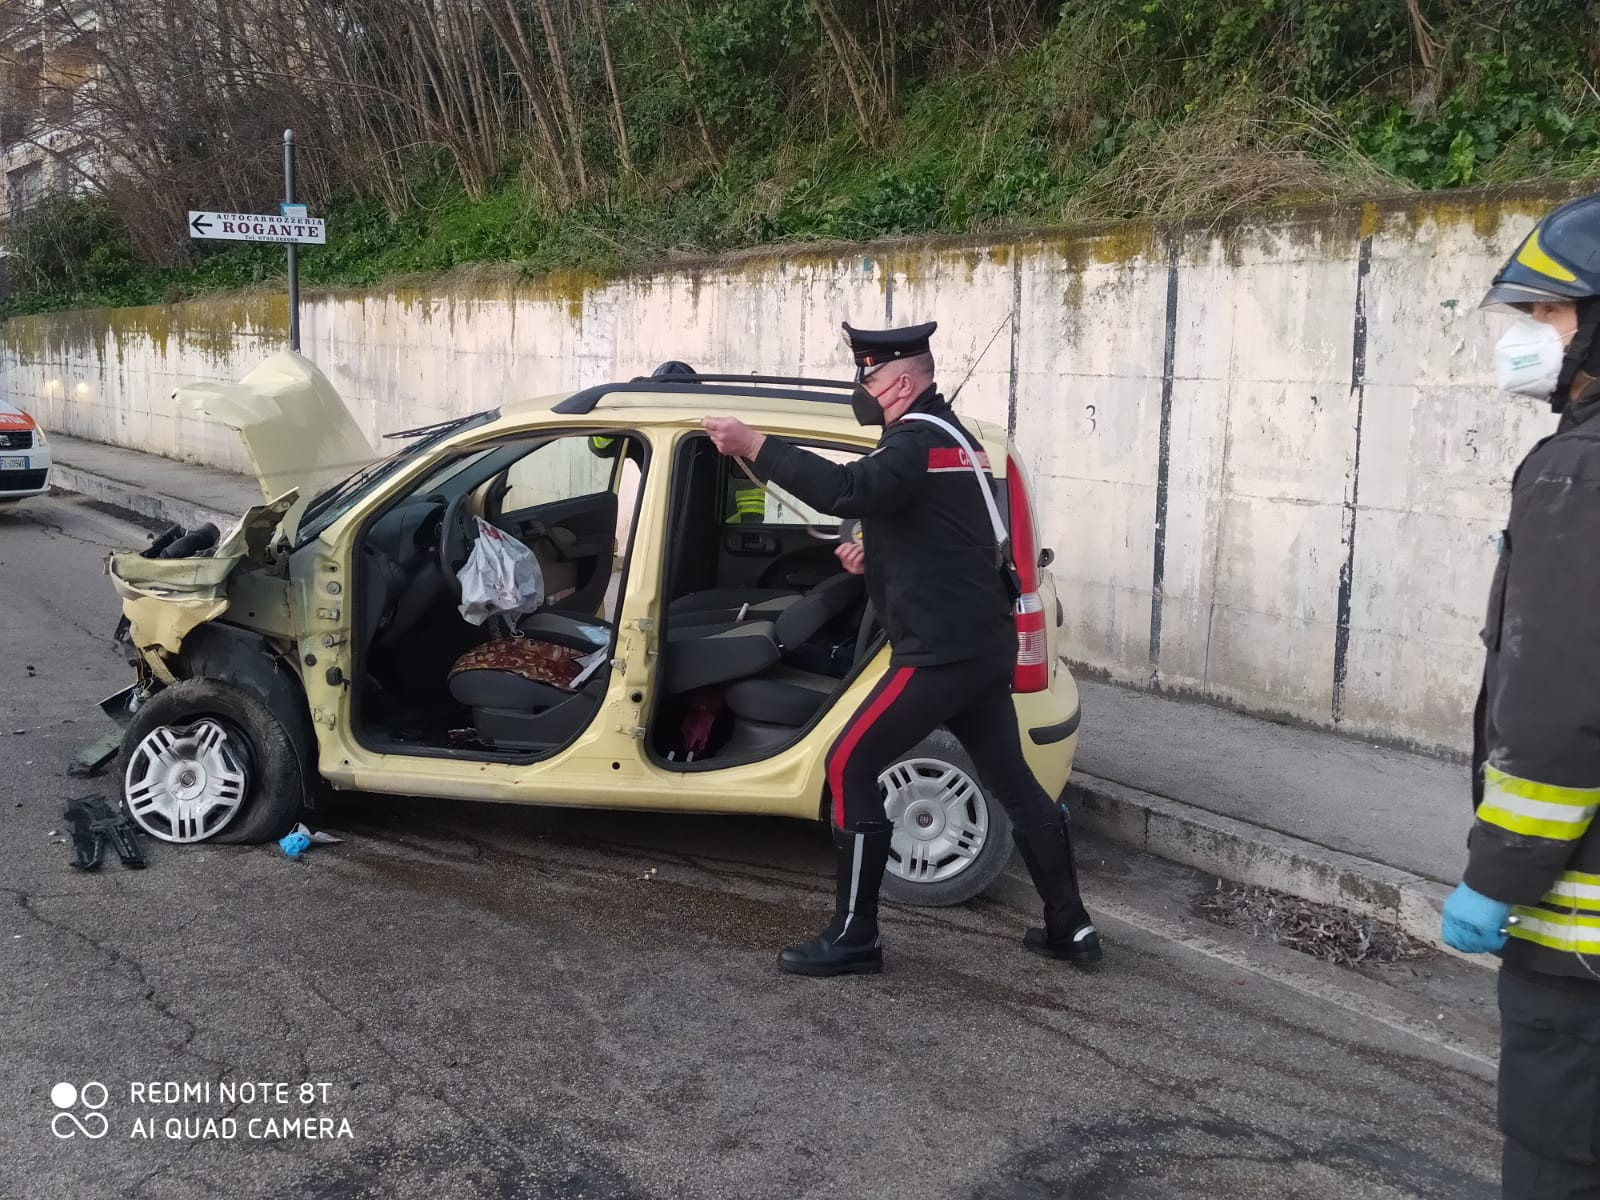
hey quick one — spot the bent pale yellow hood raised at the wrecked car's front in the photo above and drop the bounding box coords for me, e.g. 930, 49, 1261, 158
178, 350, 376, 538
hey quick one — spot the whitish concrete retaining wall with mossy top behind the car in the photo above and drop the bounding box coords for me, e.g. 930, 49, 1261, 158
0, 195, 1557, 749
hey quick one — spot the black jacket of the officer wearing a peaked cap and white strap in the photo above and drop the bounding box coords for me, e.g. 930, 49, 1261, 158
755, 387, 1016, 667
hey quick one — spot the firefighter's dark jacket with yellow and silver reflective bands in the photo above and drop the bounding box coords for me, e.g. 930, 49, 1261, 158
1466, 384, 1600, 978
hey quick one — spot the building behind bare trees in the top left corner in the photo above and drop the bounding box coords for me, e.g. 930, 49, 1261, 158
0, 0, 99, 219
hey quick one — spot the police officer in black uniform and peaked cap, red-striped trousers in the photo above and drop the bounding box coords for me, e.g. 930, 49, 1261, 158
704, 322, 1101, 974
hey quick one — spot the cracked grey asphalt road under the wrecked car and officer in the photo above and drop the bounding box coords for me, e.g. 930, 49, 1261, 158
0, 498, 1498, 1200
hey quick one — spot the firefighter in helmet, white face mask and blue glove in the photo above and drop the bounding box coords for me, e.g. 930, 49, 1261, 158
1442, 195, 1600, 1200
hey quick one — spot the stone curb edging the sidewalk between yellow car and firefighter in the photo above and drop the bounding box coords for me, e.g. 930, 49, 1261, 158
1062, 773, 1472, 968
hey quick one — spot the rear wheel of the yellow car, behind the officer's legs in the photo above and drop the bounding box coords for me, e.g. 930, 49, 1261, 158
878, 730, 1014, 907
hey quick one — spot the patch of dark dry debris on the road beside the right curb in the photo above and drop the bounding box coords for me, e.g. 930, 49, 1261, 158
1195, 880, 1424, 966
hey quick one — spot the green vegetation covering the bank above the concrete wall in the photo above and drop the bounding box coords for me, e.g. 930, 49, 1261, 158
0, 0, 1600, 314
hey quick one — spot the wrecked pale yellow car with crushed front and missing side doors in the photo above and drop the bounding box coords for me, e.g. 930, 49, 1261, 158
107, 354, 1078, 904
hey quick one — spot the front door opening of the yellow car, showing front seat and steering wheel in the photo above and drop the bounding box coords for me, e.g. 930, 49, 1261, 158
350, 430, 648, 762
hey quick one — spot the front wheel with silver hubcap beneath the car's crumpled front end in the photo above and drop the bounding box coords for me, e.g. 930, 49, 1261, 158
122, 678, 307, 845
